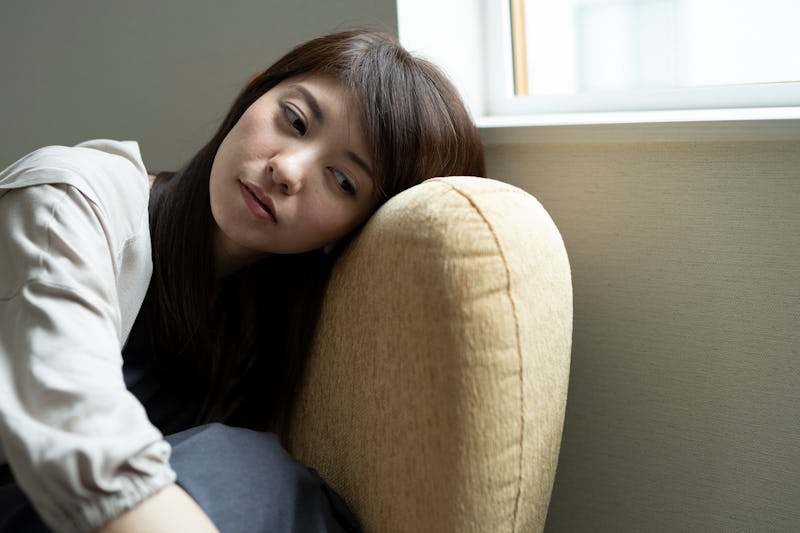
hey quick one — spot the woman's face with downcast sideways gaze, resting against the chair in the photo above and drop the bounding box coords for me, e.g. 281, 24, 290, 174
209, 75, 375, 275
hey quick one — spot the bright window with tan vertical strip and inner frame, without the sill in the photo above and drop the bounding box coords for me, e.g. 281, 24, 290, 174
485, 0, 800, 114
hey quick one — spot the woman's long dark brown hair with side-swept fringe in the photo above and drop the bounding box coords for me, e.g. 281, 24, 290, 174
146, 30, 484, 431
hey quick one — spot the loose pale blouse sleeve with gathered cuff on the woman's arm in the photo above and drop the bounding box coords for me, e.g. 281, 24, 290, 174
0, 184, 175, 531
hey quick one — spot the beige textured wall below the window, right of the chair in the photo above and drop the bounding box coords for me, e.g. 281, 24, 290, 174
488, 142, 800, 532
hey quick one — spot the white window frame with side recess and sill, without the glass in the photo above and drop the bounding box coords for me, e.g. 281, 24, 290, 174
398, 0, 800, 144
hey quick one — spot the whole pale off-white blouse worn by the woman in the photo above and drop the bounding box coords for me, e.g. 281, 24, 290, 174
0, 140, 175, 531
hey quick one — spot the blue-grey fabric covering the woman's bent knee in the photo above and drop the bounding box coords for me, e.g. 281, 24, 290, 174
167, 424, 360, 533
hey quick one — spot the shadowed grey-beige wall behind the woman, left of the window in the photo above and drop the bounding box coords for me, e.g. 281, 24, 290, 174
0, 0, 397, 170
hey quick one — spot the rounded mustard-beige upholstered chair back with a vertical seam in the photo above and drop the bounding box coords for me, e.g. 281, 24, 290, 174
287, 177, 572, 533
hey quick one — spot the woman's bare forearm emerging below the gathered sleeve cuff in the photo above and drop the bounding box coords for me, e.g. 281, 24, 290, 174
95, 484, 219, 533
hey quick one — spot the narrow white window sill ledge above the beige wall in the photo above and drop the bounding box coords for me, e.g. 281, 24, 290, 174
475, 107, 800, 146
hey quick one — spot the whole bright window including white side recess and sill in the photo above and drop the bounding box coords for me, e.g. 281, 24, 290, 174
397, 0, 800, 139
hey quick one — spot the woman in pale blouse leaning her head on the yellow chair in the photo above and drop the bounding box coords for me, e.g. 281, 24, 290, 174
0, 31, 484, 531
